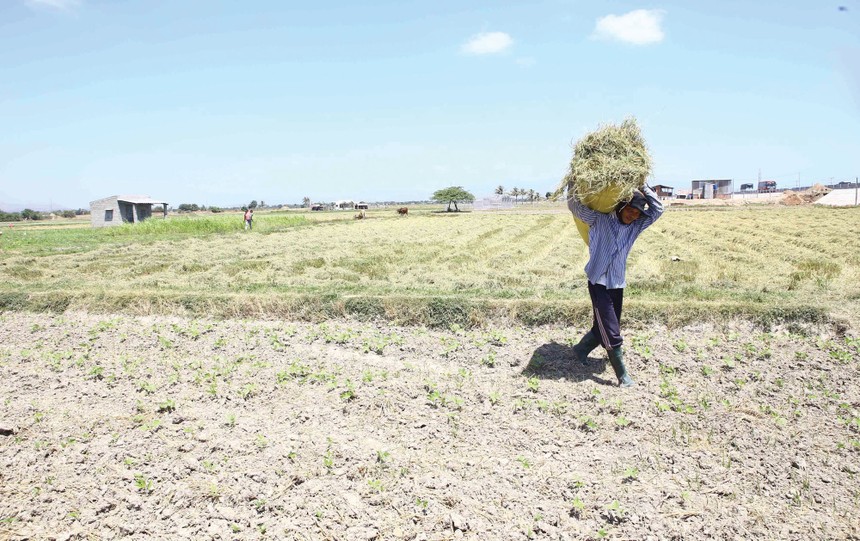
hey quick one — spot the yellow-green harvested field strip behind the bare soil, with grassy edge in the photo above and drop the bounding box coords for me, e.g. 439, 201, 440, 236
0, 207, 860, 325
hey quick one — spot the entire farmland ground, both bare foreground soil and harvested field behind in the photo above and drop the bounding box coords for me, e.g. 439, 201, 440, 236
0, 207, 860, 541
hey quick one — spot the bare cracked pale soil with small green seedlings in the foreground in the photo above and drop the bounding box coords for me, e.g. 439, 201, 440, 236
0, 313, 860, 540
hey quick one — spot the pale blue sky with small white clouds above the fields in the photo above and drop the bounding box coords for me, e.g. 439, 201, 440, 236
0, 0, 860, 210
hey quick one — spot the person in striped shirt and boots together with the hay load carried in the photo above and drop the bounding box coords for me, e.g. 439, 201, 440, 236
556, 118, 663, 387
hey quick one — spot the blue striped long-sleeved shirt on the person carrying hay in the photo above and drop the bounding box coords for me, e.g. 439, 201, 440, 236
567, 184, 663, 289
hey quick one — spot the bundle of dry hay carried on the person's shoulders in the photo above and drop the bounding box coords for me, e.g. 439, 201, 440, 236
554, 117, 651, 202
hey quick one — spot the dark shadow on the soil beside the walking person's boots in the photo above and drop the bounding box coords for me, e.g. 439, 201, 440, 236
522, 342, 615, 386
